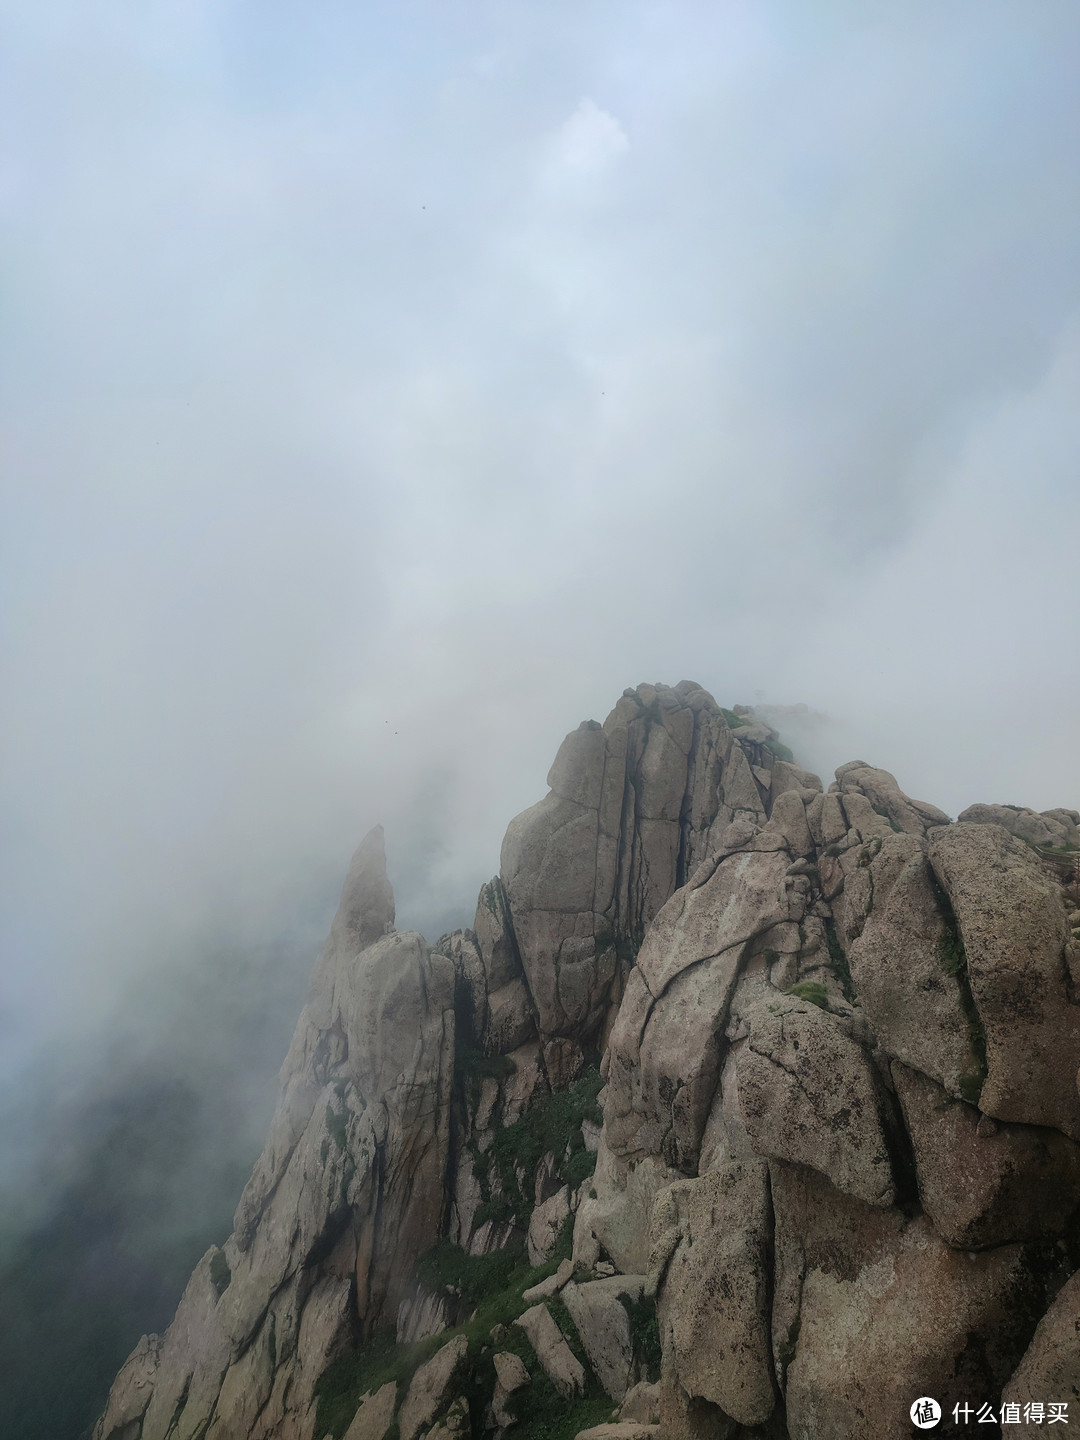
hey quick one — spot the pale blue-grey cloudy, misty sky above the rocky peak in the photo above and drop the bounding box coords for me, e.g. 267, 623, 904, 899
0, 0, 1080, 1117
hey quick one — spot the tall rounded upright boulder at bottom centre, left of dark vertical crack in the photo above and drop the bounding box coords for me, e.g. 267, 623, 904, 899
652, 1161, 775, 1426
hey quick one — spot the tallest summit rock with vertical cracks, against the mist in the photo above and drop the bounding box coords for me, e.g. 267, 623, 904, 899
498, 683, 777, 1040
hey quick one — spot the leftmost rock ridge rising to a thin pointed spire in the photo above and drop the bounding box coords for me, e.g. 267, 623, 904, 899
98, 832, 454, 1440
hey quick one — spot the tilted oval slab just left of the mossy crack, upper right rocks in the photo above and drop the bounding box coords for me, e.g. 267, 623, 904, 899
848, 847, 981, 1097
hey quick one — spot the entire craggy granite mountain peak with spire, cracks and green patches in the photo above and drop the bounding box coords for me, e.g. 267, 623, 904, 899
95, 683, 1080, 1440
